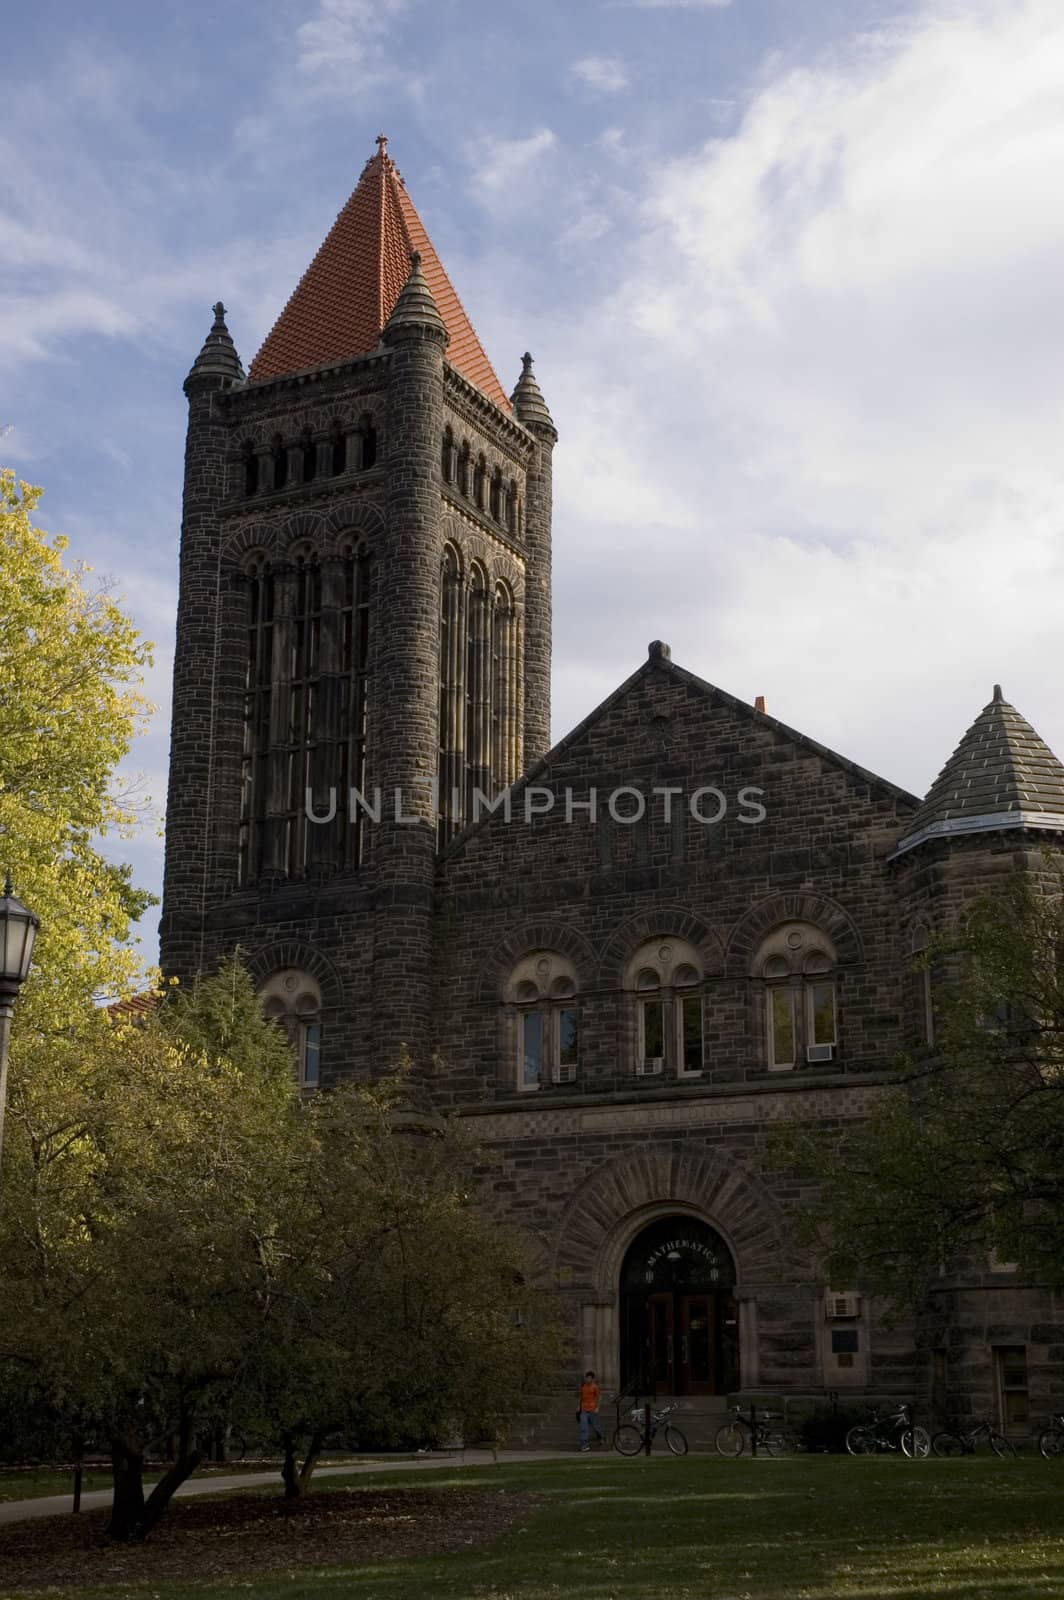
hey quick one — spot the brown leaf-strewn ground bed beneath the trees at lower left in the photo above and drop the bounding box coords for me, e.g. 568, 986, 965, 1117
0, 1488, 539, 1595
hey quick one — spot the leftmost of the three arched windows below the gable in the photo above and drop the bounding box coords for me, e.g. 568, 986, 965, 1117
506, 950, 579, 1093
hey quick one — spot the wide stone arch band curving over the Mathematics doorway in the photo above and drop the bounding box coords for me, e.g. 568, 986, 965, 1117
554, 1142, 811, 1301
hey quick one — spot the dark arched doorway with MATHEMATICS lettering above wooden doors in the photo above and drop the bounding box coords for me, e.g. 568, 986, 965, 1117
618, 1214, 739, 1395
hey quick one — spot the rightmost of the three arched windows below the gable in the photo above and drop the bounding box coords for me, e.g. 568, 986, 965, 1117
754, 922, 838, 1072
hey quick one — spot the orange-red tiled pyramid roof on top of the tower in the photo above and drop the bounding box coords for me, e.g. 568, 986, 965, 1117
248, 134, 510, 411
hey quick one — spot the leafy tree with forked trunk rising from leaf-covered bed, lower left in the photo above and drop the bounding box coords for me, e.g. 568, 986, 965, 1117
0, 962, 306, 1539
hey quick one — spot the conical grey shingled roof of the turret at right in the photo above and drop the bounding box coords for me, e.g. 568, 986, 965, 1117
898, 683, 1064, 853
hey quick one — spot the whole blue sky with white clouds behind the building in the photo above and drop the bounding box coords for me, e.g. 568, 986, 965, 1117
0, 0, 1064, 954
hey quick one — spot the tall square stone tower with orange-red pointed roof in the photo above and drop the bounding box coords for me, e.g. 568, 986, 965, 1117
162, 136, 557, 1082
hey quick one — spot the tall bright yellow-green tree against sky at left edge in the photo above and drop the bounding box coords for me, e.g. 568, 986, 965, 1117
0, 470, 150, 1017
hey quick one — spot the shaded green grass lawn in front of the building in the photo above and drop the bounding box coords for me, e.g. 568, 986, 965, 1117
0, 1456, 1064, 1600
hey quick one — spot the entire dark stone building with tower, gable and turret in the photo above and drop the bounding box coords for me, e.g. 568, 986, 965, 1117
162, 139, 1064, 1430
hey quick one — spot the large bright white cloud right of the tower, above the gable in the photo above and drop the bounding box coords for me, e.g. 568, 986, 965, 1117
538, 0, 1064, 787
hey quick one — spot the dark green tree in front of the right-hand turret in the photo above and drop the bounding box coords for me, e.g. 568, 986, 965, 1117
778, 877, 1064, 1307
